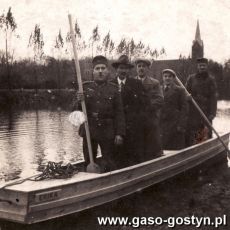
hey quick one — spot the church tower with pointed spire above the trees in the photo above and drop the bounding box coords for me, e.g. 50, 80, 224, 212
192, 20, 204, 60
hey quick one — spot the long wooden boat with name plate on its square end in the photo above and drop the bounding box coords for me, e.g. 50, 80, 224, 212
0, 133, 229, 224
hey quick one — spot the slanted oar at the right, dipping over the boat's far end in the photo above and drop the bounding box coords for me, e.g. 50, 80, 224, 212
175, 75, 230, 158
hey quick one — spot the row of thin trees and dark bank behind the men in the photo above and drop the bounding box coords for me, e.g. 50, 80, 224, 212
0, 7, 230, 98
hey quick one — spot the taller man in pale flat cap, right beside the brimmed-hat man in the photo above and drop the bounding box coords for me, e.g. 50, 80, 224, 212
135, 58, 164, 160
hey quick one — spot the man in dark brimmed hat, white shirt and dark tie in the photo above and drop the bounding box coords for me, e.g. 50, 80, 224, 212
112, 55, 145, 167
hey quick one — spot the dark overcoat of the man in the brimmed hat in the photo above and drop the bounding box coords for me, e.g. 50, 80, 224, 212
112, 78, 147, 166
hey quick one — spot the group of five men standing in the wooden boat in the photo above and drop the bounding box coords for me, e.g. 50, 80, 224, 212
76, 55, 217, 172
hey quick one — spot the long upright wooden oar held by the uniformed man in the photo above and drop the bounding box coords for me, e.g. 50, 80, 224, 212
68, 14, 100, 173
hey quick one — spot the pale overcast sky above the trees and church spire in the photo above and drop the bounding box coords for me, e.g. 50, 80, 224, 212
0, 0, 230, 62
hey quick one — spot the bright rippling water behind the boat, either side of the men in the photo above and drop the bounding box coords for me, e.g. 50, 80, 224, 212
0, 101, 230, 181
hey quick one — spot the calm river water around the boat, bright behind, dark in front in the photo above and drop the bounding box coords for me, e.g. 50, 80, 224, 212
0, 101, 230, 230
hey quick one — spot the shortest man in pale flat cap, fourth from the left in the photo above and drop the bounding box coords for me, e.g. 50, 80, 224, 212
161, 69, 188, 150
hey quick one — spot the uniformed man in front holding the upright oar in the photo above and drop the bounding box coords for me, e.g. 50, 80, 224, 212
74, 55, 125, 171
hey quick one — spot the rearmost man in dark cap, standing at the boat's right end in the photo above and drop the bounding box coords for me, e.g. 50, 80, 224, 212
186, 58, 217, 145
